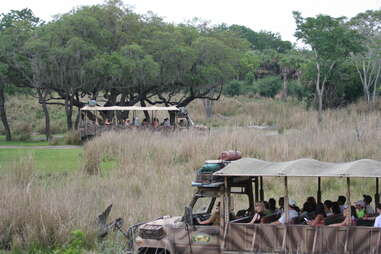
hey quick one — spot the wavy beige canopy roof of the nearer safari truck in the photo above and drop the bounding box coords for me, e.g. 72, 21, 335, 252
214, 158, 381, 178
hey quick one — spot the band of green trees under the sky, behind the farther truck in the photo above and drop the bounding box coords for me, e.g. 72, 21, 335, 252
0, 1, 381, 139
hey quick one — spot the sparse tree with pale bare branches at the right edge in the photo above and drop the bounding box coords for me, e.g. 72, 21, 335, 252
349, 10, 381, 109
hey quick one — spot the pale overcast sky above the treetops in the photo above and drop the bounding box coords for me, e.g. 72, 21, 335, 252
0, 0, 381, 42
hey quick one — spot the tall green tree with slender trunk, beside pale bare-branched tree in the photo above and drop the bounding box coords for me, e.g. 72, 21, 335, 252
293, 12, 362, 123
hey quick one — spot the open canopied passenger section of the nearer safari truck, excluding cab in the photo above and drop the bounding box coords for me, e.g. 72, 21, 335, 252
205, 158, 381, 254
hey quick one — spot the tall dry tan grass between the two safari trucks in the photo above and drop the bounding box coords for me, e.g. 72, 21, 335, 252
0, 97, 381, 250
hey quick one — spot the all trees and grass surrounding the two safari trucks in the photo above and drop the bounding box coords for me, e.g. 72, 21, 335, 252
0, 1, 381, 253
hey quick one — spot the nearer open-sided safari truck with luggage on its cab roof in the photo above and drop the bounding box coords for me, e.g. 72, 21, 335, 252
103, 158, 381, 254
